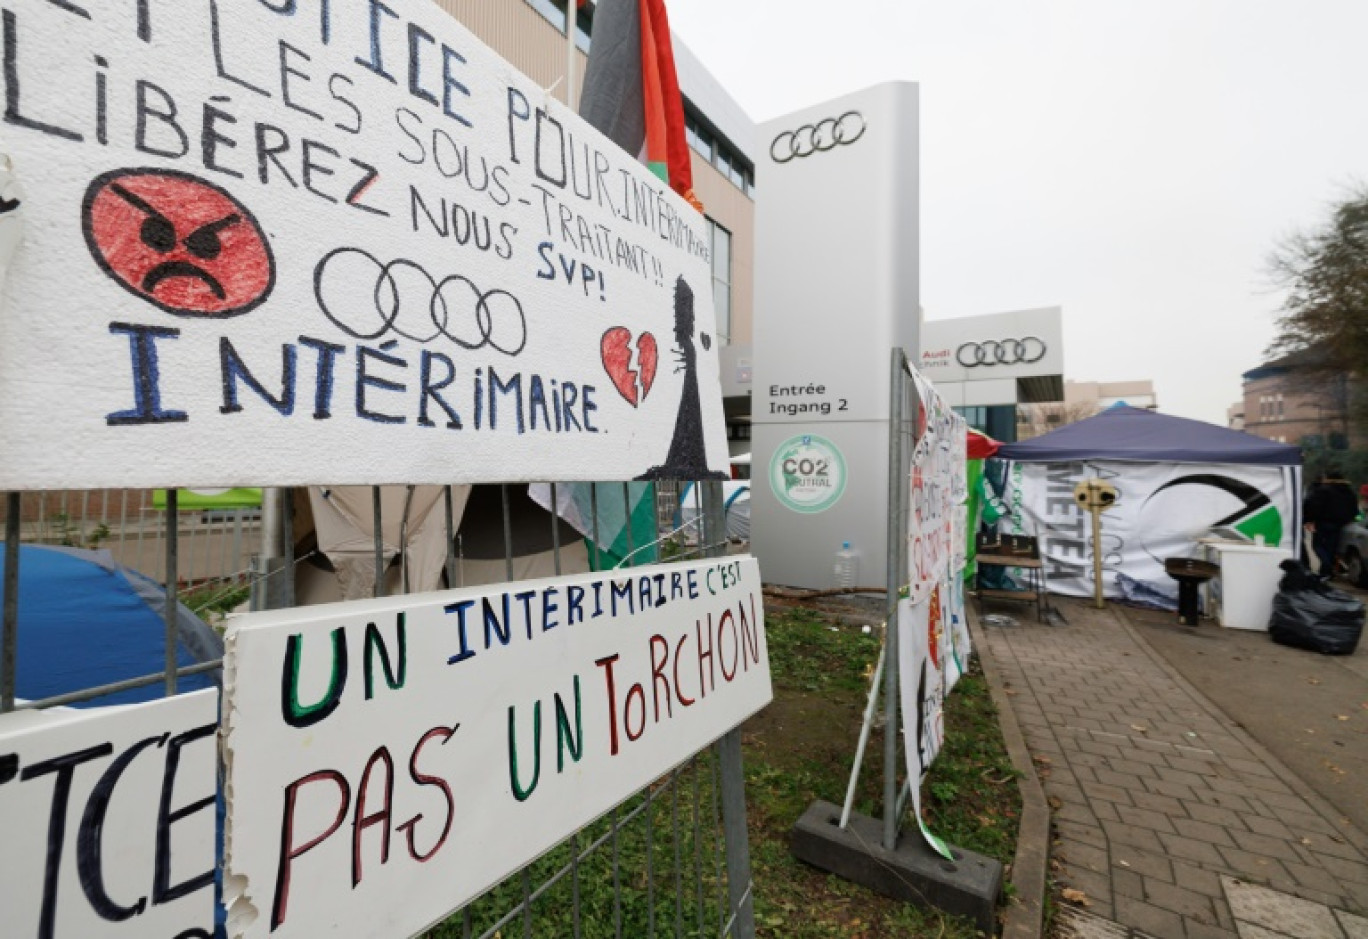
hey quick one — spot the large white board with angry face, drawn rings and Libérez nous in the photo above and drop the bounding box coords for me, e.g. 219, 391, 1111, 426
0, 0, 726, 489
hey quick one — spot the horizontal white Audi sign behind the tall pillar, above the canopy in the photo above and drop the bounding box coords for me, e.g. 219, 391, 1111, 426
918, 307, 1064, 382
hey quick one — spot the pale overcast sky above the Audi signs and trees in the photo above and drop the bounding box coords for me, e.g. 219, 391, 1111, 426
669, 0, 1368, 424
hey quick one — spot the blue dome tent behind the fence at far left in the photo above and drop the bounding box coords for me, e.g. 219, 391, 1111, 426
0, 542, 223, 706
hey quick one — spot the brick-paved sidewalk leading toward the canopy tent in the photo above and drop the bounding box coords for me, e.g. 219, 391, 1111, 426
979, 597, 1368, 939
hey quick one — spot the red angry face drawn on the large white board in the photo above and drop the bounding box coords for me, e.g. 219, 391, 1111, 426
81, 168, 275, 316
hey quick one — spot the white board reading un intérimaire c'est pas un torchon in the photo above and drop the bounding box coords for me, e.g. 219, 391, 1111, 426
224, 557, 772, 939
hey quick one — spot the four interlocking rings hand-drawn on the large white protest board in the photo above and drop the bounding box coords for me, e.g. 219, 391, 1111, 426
313, 248, 527, 356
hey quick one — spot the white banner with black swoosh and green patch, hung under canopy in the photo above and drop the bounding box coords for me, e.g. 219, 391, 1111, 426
997, 460, 1301, 606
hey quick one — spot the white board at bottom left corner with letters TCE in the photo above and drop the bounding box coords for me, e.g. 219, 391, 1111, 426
0, 689, 219, 939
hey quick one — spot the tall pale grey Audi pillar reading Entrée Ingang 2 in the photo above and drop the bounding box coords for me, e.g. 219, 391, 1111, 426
751, 82, 919, 587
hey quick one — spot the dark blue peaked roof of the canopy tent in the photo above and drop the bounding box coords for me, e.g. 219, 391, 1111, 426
996, 405, 1301, 467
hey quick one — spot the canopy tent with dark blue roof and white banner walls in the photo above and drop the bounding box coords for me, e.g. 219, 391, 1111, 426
990, 405, 1301, 606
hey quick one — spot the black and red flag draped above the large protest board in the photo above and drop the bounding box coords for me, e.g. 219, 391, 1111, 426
580, 0, 703, 212
